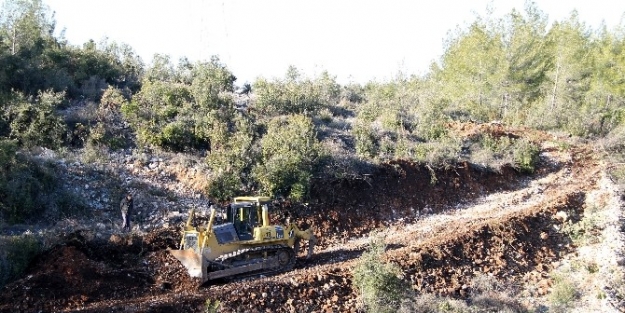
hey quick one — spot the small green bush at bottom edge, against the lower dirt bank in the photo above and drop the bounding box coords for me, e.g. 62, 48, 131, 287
353, 235, 410, 313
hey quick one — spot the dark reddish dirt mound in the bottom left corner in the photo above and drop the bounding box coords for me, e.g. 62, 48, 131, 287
0, 246, 152, 312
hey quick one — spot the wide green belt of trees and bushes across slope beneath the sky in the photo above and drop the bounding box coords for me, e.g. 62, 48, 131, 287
0, 0, 625, 222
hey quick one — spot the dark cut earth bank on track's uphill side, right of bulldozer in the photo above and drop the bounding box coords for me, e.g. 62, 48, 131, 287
308, 161, 528, 247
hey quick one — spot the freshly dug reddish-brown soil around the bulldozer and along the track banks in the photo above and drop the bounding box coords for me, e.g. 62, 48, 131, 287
0, 125, 596, 312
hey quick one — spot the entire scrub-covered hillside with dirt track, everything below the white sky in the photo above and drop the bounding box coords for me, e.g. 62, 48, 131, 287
0, 0, 625, 313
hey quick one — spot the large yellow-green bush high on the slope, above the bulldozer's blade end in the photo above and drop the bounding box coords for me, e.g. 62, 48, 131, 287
121, 58, 236, 152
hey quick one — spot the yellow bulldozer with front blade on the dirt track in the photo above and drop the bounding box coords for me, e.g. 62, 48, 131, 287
169, 197, 317, 284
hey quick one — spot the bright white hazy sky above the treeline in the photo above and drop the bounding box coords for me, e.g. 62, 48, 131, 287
31, 0, 625, 84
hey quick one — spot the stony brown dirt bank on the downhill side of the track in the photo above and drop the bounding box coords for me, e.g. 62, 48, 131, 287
389, 193, 584, 297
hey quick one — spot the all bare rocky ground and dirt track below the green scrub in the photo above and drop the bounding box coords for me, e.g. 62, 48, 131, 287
0, 124, 625, 312
